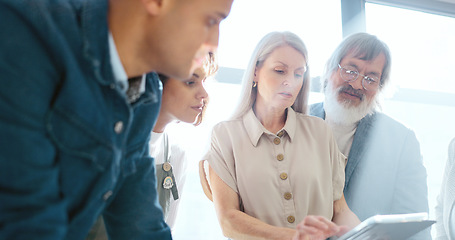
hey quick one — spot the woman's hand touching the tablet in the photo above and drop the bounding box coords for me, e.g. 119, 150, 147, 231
292, 215, 349, 240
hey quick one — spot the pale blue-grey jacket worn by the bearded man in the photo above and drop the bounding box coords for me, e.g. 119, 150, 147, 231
310, 103, 431, 239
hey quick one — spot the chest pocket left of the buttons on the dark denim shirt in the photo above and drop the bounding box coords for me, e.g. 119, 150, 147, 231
46, 105, 121, 230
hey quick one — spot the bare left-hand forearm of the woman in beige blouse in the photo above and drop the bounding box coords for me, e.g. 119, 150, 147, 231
219, 210, 295, 240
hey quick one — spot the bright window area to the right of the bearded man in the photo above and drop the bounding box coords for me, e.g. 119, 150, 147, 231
365, 3, 455, 236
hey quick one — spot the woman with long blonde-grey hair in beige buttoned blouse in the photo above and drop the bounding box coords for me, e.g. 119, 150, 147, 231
205, 32, 359, 239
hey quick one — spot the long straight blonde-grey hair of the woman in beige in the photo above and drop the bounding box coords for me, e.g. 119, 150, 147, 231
232, 31, 310, 119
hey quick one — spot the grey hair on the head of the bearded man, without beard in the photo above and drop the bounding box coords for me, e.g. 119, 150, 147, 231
322, 33, 391, 91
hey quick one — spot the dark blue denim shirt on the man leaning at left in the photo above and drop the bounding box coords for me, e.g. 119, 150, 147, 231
0, 0, 171, 239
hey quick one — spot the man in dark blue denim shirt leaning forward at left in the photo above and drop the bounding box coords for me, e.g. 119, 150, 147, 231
0, 0, 232, 239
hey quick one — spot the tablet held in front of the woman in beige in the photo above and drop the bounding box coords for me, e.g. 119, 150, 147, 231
334, 213, 436, 240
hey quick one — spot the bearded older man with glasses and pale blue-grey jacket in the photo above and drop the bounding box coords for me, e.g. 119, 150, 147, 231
310, 33, 431, 239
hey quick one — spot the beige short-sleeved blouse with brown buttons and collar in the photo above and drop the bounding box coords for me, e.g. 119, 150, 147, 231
204, 108, 346, 228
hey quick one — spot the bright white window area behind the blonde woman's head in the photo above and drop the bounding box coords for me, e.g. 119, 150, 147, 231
218, 0, 342, 76
